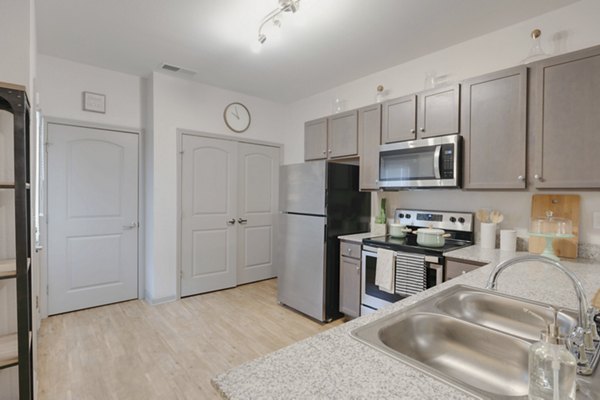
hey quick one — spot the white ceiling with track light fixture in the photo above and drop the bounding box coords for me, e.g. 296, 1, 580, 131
36, 0, 576, 102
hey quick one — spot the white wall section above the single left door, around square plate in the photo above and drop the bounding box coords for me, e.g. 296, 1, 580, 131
37, 54, 142, 129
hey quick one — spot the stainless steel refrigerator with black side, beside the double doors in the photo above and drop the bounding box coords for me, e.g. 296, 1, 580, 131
275, 161, 371, 321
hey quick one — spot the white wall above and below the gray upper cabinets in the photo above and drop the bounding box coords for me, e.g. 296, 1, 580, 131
285, 0, 600, 244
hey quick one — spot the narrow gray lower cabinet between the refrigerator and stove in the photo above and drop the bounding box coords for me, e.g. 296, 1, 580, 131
340, 241, 361, 318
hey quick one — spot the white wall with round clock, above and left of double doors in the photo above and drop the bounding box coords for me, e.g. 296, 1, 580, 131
146, 73, 287, 302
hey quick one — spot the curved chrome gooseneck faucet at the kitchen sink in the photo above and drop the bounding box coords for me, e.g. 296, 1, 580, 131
486, 255, 600, 375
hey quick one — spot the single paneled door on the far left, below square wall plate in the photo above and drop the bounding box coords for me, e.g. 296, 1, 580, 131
48, 124, 138, 314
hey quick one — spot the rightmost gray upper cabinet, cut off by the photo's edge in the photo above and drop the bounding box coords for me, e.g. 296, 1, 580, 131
530, 46, 600, 189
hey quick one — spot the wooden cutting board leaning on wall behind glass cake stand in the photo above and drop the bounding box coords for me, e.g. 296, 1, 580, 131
529, 194, 581, 258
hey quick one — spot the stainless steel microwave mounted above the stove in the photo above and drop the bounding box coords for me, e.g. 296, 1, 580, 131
379, 135, 461, 189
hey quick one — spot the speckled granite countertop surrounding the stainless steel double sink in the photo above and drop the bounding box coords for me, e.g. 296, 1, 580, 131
213, 252, 600, 400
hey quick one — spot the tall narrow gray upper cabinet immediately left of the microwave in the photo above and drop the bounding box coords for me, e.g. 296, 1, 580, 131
358, 104, 381, 190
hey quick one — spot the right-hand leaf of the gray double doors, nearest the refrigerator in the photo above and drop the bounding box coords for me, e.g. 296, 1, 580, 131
237, 143, 279, 284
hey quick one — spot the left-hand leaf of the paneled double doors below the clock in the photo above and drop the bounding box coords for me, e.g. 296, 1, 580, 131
181, 135, 237, 296
